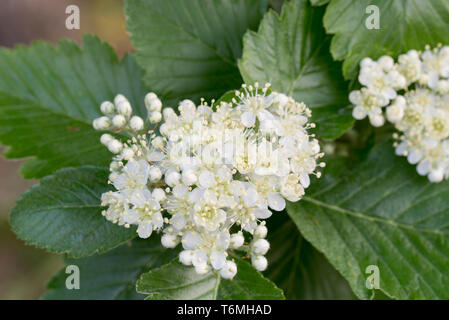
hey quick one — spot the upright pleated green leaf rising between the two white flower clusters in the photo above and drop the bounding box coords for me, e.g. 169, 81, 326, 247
239, 0, 353, 139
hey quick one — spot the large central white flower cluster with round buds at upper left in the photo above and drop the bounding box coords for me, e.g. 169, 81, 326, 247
94, 84, 324, 278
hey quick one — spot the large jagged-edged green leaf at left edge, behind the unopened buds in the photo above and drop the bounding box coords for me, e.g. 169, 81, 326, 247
0, 36, 146, 178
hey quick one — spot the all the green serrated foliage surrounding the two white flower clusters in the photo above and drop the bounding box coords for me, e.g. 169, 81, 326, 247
0, 0, 449, 299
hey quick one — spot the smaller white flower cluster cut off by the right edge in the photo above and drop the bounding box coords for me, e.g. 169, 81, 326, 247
349, 45, 449, 182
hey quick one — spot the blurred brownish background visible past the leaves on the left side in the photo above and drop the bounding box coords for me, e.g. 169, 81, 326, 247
0, 0, 132, 299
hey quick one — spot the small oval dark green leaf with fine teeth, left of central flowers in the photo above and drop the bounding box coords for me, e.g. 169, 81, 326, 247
10, 166, 136, 257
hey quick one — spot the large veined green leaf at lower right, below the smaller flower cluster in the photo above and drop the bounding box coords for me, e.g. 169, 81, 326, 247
287, 144, 449, 299
